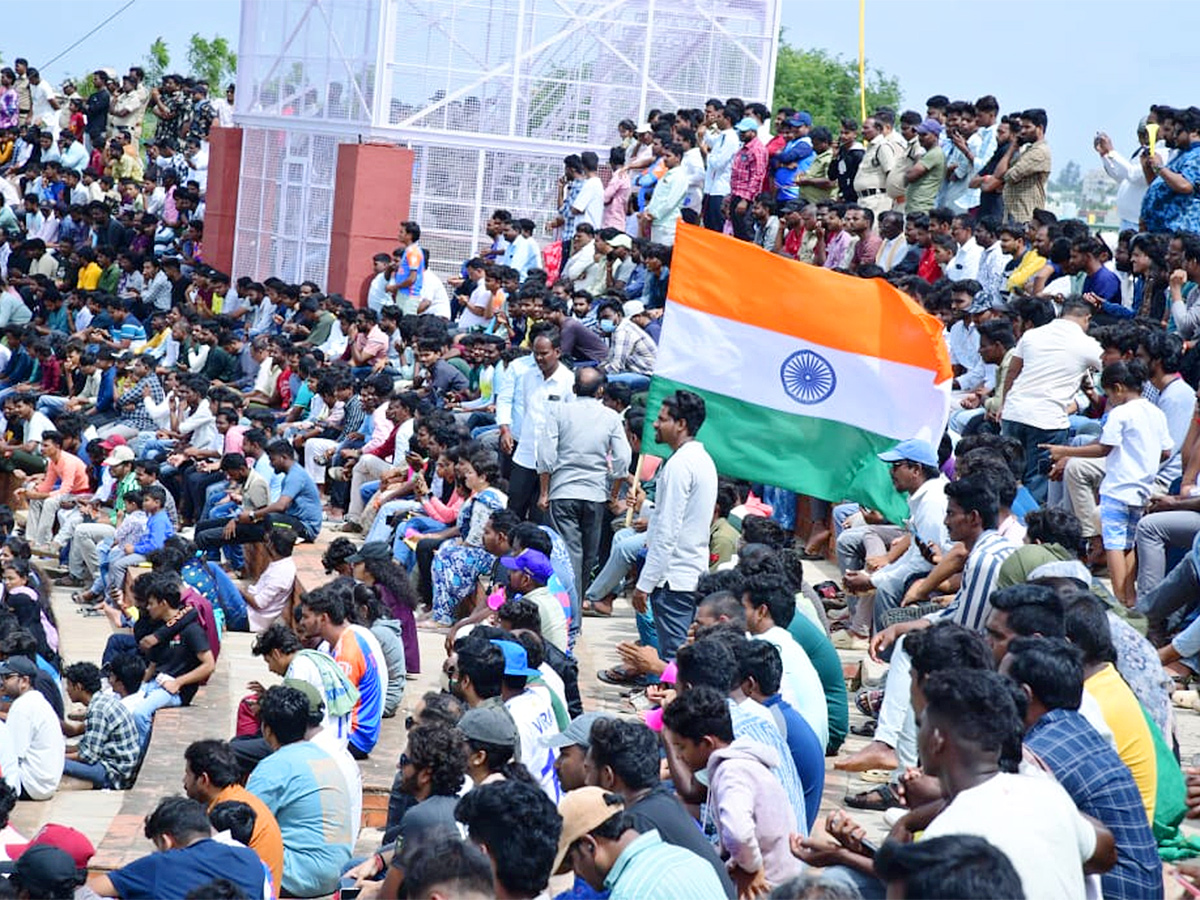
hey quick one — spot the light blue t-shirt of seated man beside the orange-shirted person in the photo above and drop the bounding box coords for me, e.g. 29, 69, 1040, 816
246, 740, 354, 896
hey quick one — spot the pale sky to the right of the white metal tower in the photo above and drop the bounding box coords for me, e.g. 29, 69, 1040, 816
784, 0, 1200, 173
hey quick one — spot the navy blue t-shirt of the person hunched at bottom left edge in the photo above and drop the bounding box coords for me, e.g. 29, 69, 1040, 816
108, 838, 264, 900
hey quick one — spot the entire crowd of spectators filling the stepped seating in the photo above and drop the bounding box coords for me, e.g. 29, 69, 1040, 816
0, 42, 1200, 899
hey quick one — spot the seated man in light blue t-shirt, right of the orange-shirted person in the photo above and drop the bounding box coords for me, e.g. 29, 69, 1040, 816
246, 686, 359, 896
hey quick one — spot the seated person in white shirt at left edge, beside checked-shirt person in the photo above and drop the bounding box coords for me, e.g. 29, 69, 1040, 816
0, 656, 66, 800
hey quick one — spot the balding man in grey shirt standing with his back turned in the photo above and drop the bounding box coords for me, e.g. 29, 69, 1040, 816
538, 367, 631, 635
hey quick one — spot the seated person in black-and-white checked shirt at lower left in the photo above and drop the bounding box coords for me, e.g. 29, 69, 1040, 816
62, 662, 142, 791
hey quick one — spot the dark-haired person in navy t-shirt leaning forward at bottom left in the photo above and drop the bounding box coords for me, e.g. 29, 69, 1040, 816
88, 797, 266, 900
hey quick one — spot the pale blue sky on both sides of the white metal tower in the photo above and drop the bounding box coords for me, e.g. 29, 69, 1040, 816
11, 0, 1200, 169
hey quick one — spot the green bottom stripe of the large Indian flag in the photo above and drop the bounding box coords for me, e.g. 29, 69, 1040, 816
642, 376, 908, 522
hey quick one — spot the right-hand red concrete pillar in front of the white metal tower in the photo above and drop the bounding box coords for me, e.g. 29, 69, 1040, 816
328, 144, 414, 306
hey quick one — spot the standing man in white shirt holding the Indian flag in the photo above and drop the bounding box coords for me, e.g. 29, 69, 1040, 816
631, 390, 716, 662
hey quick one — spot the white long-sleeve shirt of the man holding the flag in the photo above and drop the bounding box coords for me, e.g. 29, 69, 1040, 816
637, 440, 716, 593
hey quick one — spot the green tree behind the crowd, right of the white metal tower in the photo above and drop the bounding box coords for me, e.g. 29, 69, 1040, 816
775, 36, 902, 127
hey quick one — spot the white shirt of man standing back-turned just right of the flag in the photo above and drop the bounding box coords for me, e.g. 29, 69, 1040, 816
1003, 319, 1102, 431
